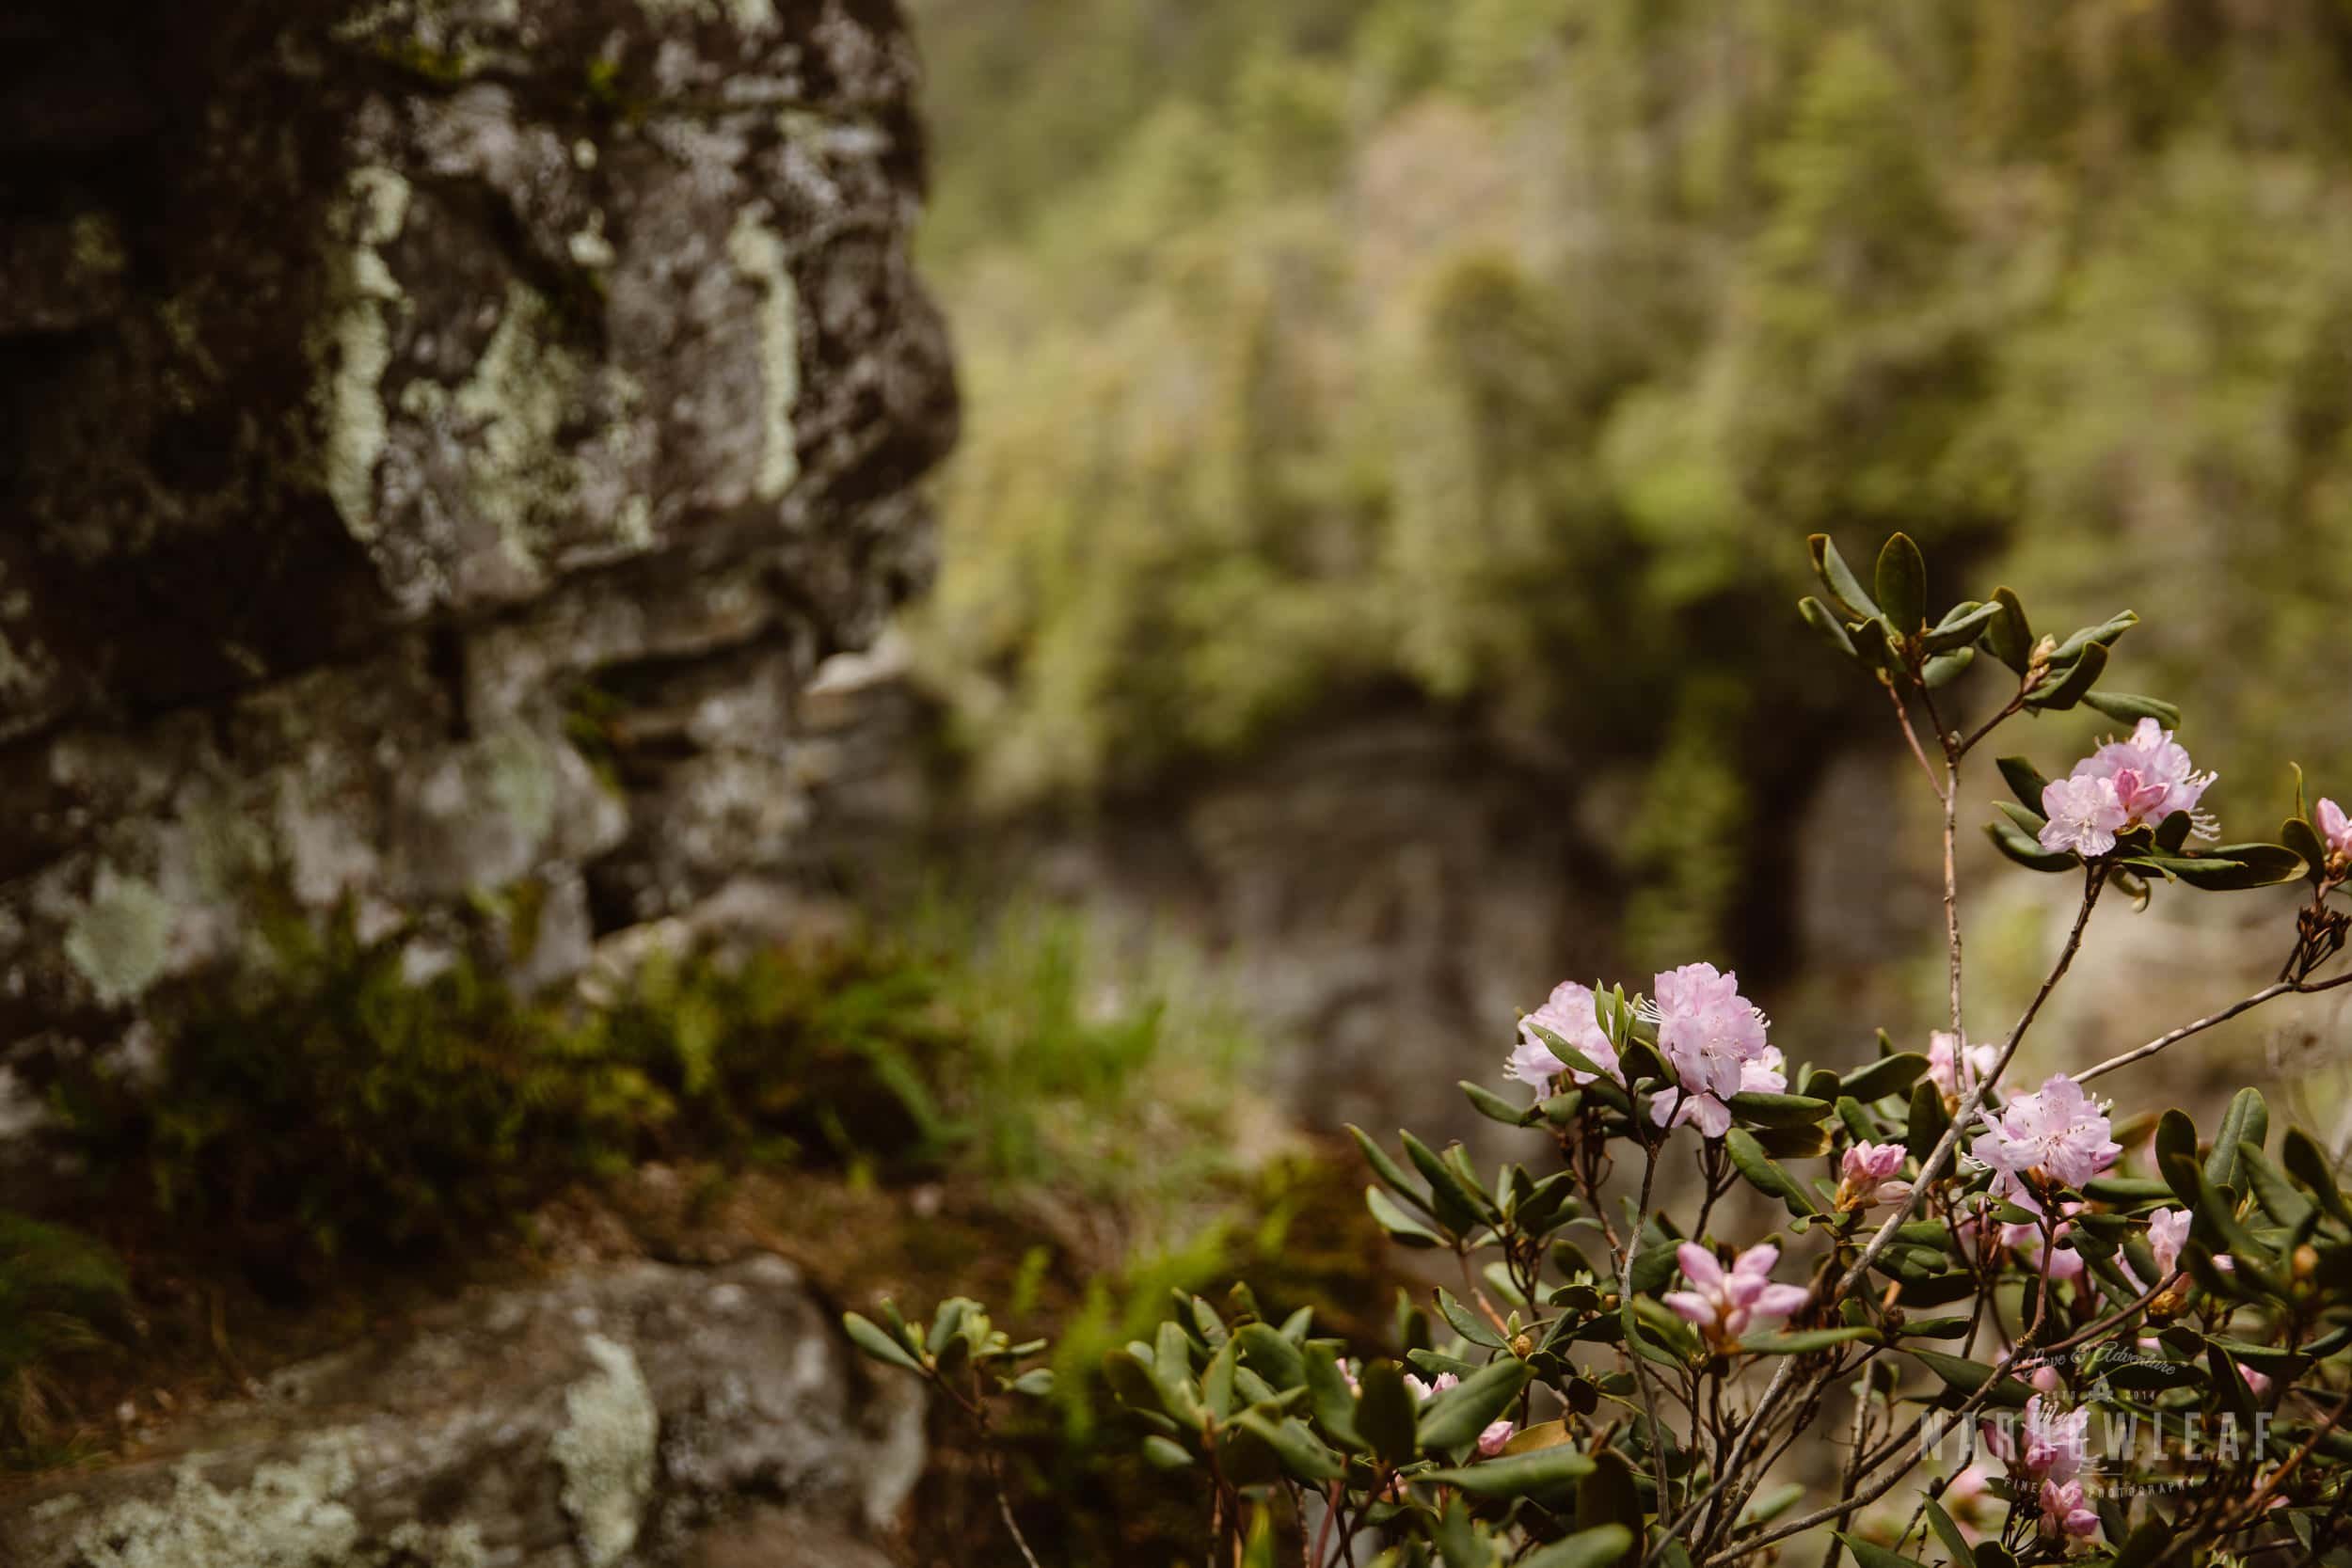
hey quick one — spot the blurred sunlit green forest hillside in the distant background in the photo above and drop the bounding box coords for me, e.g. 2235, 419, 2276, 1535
915, 0, 2352, 933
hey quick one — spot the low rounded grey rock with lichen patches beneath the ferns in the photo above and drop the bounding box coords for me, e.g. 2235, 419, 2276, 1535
0, 1256, 922, 1568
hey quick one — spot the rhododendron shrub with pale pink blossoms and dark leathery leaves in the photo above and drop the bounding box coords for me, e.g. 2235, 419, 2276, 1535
850, 533, 2352, 1568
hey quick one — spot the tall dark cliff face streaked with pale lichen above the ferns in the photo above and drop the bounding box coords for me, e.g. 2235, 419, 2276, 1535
0, 0, 955, 1060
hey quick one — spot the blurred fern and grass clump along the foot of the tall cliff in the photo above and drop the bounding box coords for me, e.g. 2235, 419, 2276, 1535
45, 893, 1245, 1288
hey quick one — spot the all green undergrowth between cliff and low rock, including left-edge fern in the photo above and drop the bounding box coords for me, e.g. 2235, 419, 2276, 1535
0, 908, 1284, 1467
